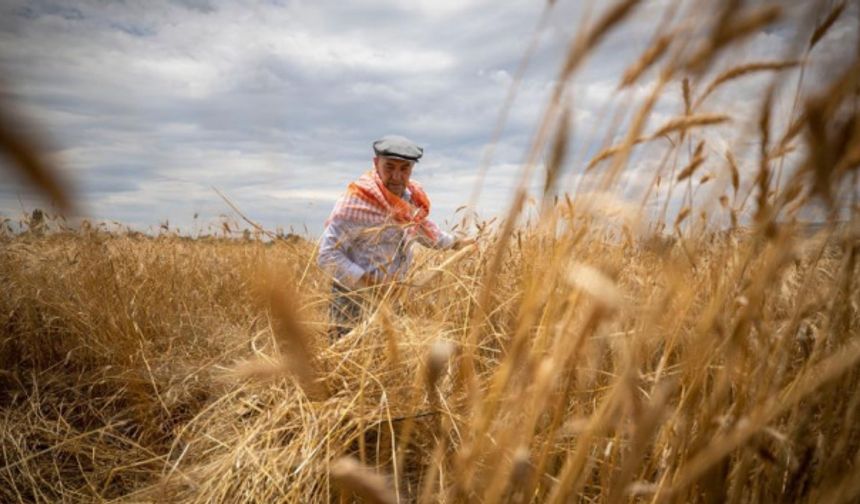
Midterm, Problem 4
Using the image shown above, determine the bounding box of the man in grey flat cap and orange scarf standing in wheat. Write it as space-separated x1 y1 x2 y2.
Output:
318 135 474 339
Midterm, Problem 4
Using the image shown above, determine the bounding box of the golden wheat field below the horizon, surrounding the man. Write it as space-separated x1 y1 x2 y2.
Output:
0 222 860 502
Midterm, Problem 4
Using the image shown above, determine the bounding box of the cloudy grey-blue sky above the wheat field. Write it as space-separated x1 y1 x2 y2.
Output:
0 0 857 235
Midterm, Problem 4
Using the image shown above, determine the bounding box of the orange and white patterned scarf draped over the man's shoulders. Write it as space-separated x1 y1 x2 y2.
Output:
325 170 439 242
